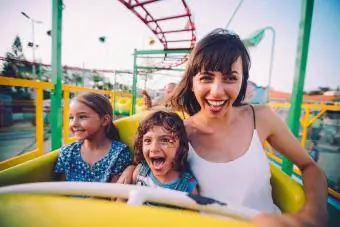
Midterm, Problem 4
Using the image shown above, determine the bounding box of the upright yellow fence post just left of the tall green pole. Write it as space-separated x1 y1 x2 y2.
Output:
35 88 44 156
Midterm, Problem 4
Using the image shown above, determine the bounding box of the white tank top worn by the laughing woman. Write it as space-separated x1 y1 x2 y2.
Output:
188 129 280 213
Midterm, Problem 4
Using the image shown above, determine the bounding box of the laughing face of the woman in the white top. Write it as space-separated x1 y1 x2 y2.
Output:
192 57 243 117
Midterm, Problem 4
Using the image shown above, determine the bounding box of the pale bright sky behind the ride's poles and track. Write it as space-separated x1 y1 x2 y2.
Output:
0 0 340 92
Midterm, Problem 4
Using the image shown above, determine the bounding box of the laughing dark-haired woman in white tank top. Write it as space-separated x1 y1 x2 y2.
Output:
168 29 327 226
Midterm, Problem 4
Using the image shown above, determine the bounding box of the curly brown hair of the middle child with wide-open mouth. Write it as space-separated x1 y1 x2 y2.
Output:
134 111 189 172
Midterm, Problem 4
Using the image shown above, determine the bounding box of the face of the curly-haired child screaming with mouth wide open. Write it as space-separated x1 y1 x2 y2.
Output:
143 126 179 177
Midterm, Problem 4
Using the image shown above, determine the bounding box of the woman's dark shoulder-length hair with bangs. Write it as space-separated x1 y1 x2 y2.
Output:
167 28 250 115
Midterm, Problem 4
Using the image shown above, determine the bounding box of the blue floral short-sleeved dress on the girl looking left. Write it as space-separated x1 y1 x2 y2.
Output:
55 140 132 182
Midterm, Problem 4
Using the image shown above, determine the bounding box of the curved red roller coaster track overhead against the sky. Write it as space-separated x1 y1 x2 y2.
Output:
119 0 196 68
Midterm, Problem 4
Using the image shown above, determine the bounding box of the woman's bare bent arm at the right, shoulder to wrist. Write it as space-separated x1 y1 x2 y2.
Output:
256 106 327 226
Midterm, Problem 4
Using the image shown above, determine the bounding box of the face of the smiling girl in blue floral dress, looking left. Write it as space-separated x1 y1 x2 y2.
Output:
70 100 104 140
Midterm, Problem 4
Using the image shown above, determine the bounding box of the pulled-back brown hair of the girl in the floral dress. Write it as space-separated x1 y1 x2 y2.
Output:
75 93 119 140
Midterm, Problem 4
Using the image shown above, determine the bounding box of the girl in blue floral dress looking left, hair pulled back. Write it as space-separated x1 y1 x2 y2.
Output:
55 93 132 182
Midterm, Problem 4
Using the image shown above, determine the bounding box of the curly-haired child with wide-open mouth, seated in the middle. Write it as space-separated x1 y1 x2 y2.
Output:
133 111 197 194
